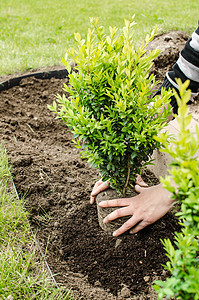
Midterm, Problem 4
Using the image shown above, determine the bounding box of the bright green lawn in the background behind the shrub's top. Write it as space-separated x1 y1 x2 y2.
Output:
0 0 198 75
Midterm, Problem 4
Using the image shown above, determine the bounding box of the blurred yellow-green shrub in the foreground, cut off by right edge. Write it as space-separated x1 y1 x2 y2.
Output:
155 80 199 300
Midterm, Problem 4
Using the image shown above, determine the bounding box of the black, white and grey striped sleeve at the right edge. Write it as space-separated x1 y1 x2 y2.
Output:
155 27 199 113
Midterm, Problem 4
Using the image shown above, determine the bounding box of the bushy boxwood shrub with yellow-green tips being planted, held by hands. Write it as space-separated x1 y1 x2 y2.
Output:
49 18 171 194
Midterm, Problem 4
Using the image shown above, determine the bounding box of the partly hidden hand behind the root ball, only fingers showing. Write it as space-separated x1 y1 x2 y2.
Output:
90 175 148 204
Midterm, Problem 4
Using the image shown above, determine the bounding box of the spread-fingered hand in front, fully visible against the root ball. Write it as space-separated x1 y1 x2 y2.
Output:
99 184 174 236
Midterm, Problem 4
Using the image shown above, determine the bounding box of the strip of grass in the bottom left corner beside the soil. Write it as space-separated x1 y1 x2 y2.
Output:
0 146 74 300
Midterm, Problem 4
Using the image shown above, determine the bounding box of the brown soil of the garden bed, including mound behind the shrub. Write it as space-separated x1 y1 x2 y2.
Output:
0 32 191 300
